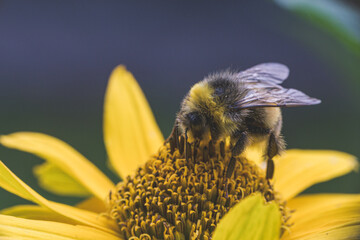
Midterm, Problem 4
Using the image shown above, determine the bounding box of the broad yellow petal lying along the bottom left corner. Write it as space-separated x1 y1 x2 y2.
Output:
0 215 121 240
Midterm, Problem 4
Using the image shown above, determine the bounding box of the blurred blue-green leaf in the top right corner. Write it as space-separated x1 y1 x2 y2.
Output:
275 0 360 56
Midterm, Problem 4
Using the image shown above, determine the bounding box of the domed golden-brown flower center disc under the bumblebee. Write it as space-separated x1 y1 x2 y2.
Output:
109 137 282 240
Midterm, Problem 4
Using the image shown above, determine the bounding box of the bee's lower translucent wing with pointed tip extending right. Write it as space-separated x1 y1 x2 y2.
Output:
235 85 321 108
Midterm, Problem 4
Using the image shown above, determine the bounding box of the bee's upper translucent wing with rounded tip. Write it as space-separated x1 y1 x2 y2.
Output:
237 63 289 88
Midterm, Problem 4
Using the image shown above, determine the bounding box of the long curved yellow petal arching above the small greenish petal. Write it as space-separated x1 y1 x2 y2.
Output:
0 132 114 200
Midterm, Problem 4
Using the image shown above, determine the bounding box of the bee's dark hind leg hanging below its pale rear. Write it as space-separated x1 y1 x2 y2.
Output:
266 132 284 180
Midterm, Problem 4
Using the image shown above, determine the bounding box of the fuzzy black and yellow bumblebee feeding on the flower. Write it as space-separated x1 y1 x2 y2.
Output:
170 63 321 179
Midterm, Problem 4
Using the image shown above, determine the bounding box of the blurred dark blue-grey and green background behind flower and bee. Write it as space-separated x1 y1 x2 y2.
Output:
0 0 360 209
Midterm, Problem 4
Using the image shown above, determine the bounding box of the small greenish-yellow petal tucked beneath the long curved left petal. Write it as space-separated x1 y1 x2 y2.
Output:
33 162 91 197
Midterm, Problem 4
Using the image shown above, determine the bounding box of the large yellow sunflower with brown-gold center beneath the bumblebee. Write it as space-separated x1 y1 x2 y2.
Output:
0 66 360 240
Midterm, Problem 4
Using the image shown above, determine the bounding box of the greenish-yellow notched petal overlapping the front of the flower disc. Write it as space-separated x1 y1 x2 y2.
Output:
213 194 281 240
